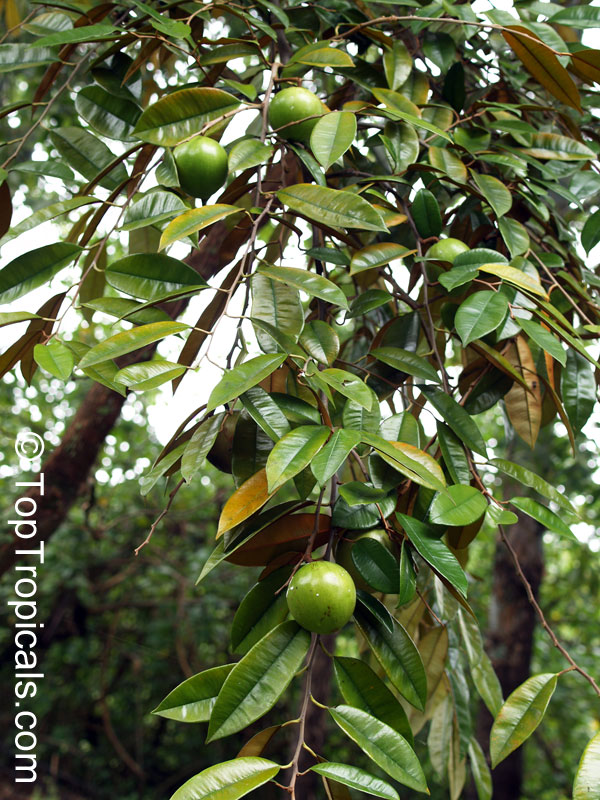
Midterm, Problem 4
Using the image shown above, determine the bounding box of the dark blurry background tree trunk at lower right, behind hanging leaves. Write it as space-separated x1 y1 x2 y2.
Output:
477 516 544 800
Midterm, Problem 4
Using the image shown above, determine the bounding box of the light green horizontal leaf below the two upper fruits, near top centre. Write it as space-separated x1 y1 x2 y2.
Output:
277 183 387 232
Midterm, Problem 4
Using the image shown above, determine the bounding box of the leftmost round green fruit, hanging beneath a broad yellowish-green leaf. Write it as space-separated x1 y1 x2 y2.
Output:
173 136 227 200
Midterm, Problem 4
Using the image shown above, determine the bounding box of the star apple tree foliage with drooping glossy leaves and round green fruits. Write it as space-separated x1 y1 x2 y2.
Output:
0 0 600 800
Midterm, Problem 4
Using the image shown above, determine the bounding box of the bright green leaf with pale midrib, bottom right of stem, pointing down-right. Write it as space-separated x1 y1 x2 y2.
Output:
329 706 428 792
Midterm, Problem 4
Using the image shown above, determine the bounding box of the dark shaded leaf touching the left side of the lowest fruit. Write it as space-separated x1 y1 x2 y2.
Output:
231 567 290 655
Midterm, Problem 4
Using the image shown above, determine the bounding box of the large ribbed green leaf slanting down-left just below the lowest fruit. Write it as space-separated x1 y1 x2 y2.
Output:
207 620 310 742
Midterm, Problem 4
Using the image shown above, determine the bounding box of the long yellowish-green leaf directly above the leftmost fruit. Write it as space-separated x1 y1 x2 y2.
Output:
133 86 239 147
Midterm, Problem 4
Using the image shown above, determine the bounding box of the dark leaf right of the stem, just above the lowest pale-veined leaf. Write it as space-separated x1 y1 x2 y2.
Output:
333 656 413 746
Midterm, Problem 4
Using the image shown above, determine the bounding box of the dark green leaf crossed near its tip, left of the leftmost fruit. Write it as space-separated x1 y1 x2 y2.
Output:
48 126 127 191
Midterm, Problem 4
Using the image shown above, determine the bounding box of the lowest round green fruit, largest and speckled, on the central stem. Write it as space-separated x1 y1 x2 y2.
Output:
286 561 356 633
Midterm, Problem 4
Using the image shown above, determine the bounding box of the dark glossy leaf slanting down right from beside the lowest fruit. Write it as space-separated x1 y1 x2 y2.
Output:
354 606 427 711
